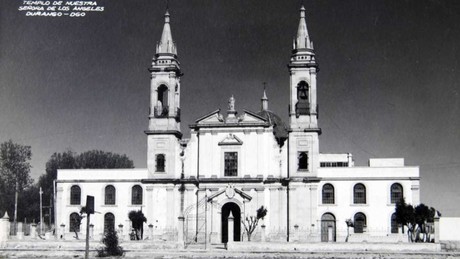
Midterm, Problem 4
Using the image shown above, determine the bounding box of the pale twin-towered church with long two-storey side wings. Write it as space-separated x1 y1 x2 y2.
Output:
55 7 420 246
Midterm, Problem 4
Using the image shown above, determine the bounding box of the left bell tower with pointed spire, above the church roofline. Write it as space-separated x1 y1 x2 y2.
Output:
145 10 183 178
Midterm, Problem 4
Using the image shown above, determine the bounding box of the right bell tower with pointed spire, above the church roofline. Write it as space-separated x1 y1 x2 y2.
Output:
288 6 321 177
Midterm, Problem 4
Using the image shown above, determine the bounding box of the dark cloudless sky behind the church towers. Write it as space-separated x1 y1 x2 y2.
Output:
0 0 460 216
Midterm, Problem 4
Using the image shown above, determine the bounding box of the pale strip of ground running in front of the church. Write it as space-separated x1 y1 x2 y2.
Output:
0 241 460 259
